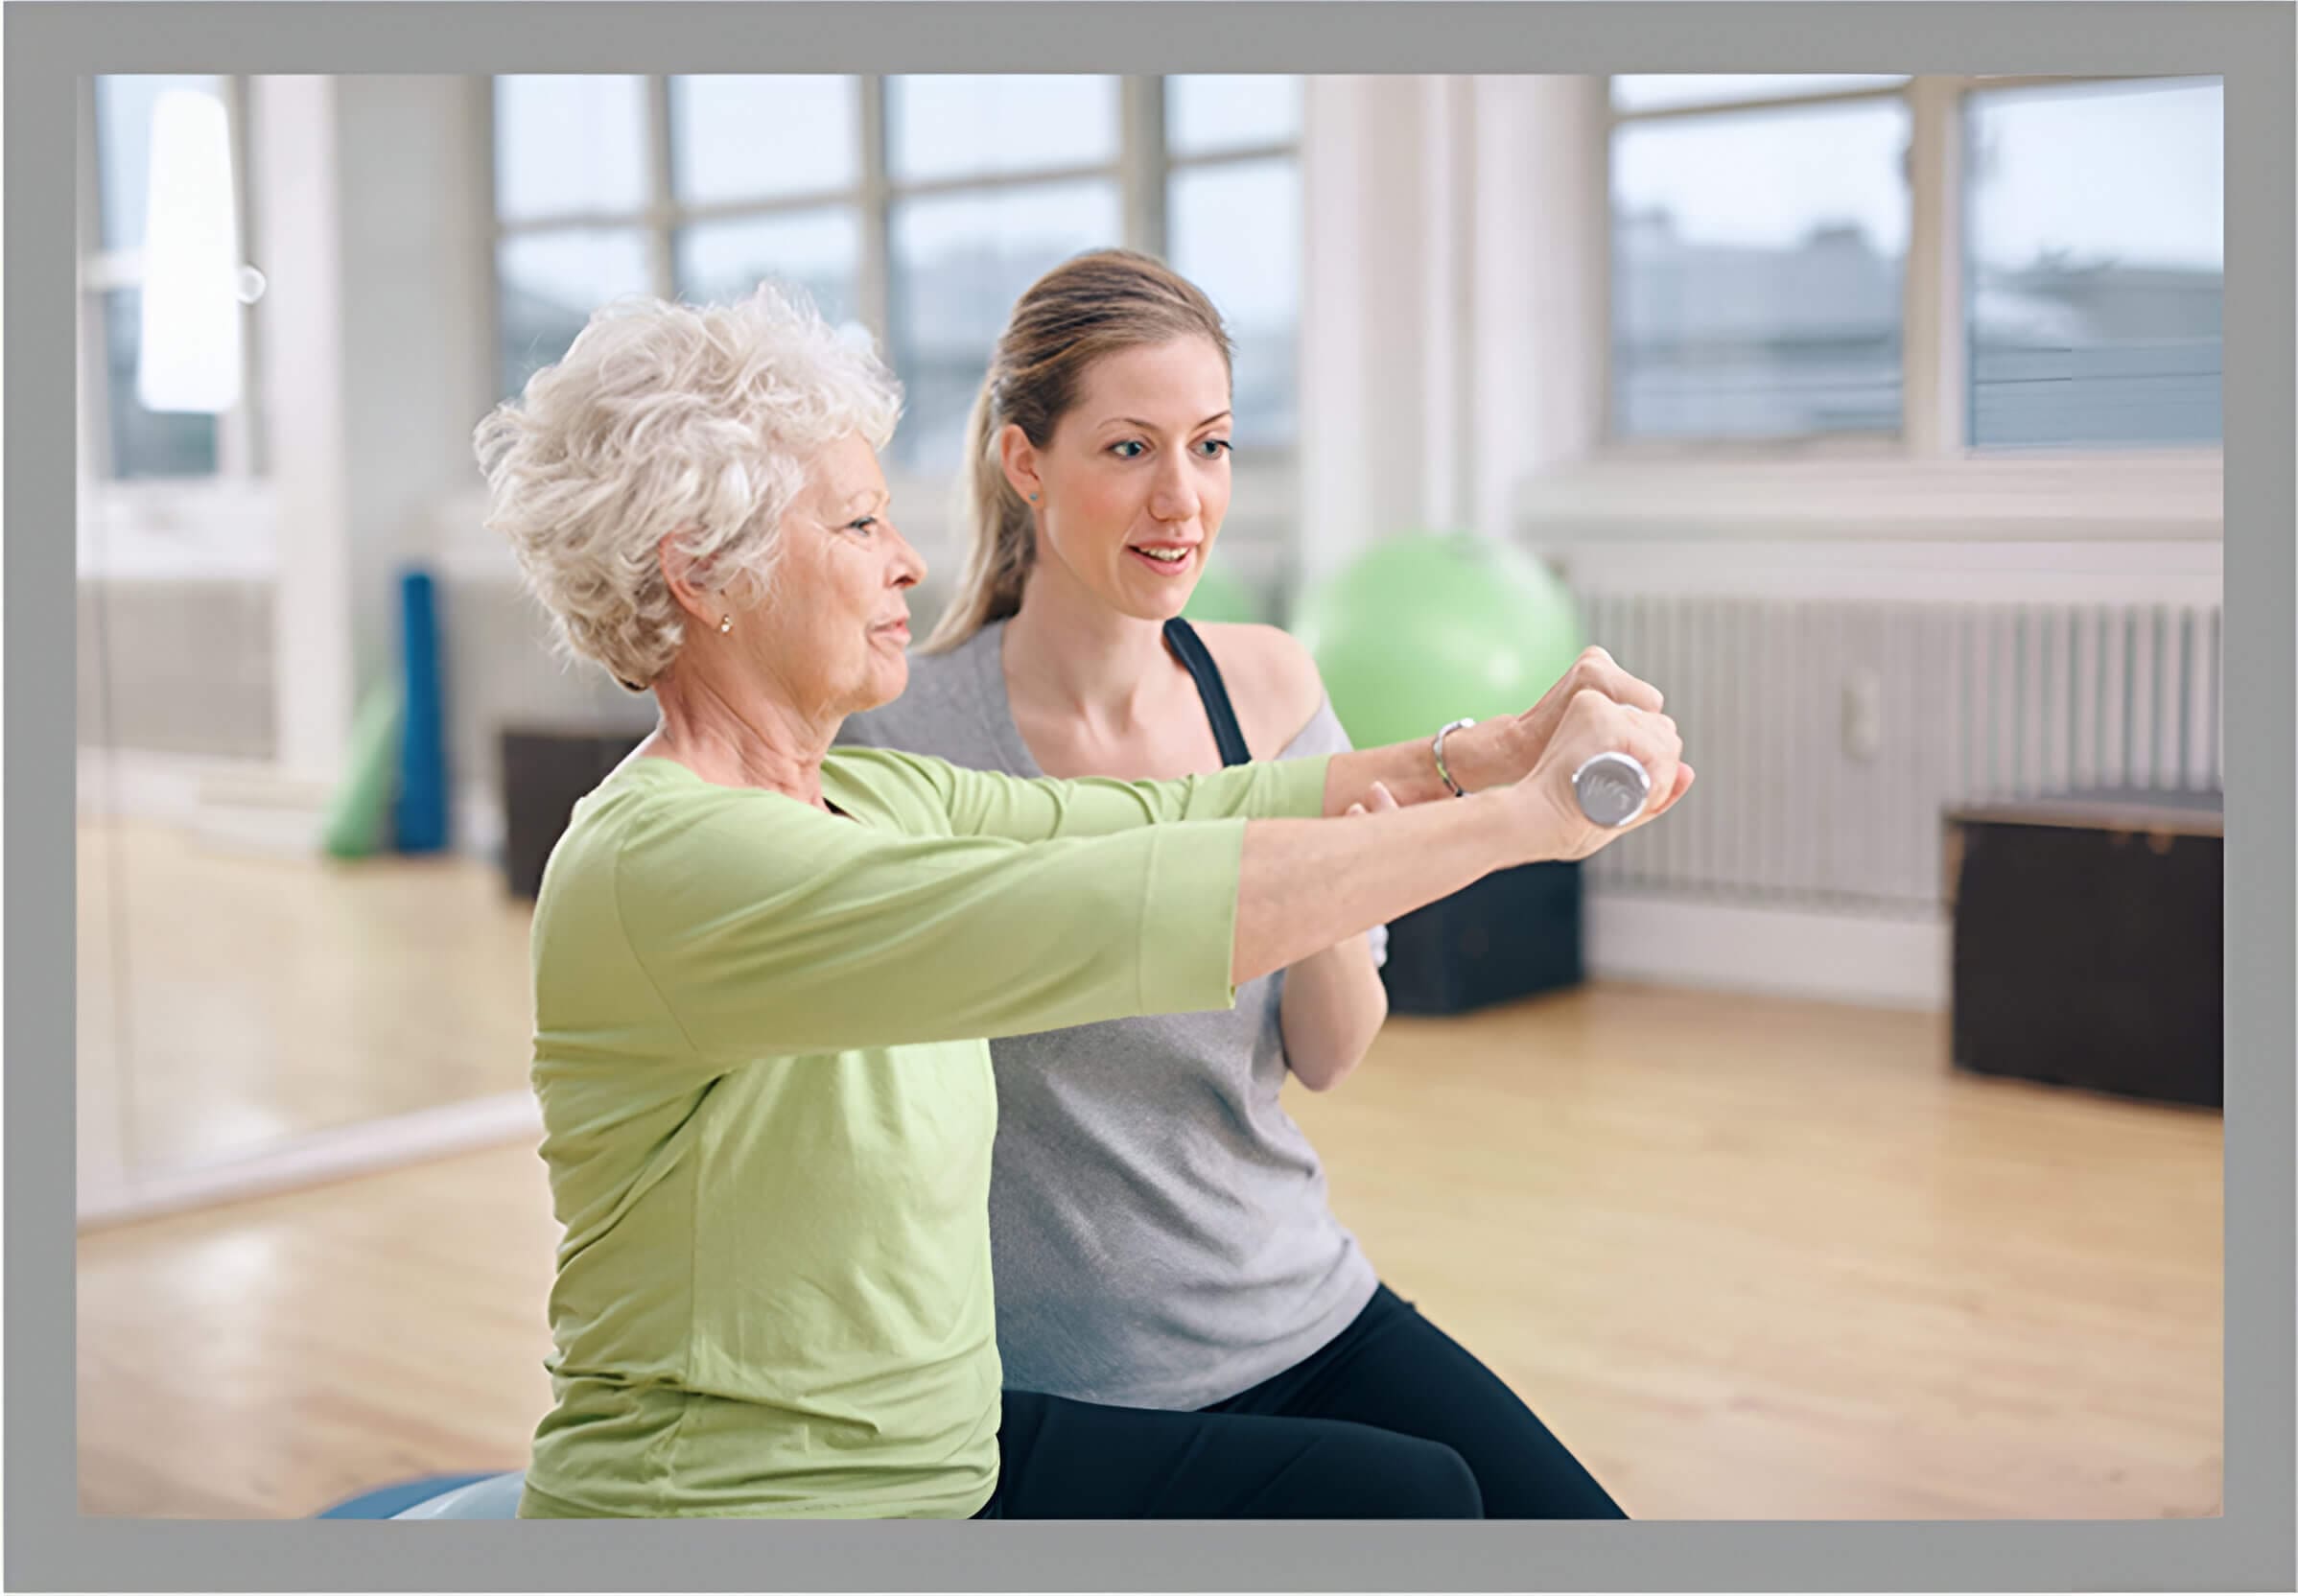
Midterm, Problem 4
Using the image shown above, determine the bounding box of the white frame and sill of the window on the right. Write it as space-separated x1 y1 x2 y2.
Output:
1516 74 2224 540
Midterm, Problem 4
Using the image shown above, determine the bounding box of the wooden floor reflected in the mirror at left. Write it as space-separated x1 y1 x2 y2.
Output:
76 816 533 1186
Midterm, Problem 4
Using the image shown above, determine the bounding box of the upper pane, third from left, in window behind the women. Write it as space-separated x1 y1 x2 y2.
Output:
884 74 1116 181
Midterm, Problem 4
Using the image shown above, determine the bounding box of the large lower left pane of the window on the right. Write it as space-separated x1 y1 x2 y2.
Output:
1611 101 1908 437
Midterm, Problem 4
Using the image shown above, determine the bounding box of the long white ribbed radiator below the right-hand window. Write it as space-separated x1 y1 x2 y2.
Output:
1574 588 2224 920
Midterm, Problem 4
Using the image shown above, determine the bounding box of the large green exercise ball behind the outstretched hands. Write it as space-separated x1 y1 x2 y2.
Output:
1292 533 1581 747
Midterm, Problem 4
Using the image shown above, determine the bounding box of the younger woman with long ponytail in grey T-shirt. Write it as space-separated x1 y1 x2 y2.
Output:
841 250 1659 1517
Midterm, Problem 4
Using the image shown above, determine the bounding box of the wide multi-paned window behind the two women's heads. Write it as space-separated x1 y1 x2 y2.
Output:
494 74 1301 474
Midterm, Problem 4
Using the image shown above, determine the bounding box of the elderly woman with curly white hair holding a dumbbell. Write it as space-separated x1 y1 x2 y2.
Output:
478 290 1689 1517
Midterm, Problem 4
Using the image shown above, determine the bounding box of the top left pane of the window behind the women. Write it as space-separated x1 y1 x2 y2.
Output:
494 76 648 221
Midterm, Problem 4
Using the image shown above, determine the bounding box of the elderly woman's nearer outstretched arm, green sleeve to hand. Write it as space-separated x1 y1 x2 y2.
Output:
583 692 1682 1058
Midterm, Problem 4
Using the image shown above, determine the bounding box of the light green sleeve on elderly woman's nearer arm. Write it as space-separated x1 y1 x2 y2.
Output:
597 770 1315 1060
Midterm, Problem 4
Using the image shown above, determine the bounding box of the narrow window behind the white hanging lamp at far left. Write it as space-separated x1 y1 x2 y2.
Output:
78 74 253 481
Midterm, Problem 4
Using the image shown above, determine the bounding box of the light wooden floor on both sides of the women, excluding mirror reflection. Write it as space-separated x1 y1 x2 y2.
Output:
78 987 2222 1517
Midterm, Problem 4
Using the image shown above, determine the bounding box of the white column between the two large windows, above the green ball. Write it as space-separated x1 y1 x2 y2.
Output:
1299 76 1611 582
